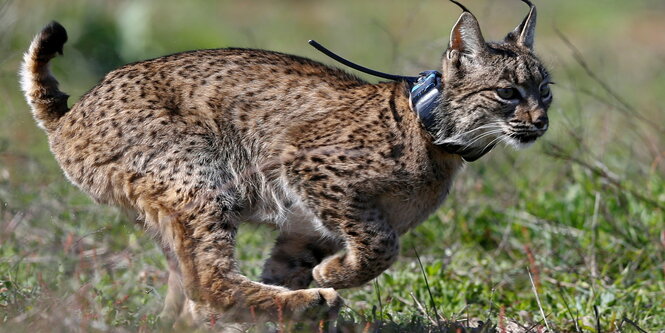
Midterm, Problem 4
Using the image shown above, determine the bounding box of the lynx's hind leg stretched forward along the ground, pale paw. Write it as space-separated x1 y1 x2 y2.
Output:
160 198 342 323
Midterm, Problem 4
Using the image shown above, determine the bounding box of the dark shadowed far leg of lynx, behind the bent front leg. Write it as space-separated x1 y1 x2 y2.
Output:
261 232 341 290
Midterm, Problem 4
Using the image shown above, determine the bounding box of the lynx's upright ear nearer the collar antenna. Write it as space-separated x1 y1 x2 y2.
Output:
449 11 487 57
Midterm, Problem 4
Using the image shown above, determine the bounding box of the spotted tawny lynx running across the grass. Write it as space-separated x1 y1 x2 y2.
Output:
21 0 552 322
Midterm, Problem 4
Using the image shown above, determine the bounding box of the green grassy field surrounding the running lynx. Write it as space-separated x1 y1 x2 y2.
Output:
0 0 665 332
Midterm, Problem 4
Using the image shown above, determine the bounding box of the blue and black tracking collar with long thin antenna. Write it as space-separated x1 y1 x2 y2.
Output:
309 40 494 162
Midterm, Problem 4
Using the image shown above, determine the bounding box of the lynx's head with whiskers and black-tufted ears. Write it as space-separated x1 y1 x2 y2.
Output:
435 0 552 161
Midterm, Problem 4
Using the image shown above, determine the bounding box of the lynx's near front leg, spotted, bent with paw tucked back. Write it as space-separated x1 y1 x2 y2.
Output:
287 153 399 289
